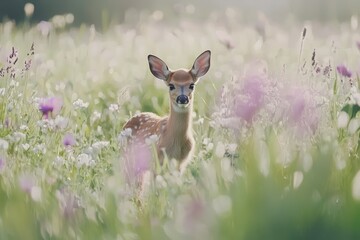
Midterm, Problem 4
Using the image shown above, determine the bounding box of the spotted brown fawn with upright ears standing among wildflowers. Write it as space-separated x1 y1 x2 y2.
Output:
123 50 211 171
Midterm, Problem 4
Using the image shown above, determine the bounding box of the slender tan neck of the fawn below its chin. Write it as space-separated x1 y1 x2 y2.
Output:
166 101 193 139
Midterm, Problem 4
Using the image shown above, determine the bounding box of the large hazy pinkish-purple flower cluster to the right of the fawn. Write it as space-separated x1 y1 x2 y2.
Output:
213 62 321 133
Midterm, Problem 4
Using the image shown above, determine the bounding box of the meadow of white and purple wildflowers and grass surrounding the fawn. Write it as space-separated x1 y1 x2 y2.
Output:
0 9 360 240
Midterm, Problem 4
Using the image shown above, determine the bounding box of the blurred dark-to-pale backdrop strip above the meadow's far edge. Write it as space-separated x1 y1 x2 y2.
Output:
0 0 360 26
